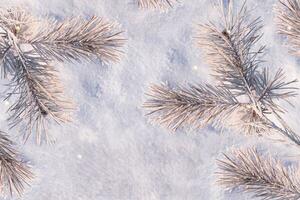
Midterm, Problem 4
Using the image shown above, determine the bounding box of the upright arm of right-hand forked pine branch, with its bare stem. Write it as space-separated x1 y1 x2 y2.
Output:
198 1 300 145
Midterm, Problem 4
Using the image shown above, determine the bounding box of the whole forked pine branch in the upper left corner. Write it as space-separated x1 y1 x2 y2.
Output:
0 8 125 143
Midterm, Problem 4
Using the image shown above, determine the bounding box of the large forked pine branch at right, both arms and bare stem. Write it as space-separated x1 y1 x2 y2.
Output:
144 1 300 145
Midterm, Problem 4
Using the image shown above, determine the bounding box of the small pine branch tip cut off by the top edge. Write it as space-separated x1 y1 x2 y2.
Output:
138 0 178 10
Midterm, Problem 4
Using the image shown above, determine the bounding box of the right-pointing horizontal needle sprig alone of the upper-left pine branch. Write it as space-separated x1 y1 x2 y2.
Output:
25 16 125 62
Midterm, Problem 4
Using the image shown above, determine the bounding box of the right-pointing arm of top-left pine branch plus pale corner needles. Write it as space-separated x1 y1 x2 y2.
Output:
0 8 125 62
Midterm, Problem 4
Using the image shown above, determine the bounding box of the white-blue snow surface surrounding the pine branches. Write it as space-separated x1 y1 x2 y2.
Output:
0 0 300 200
